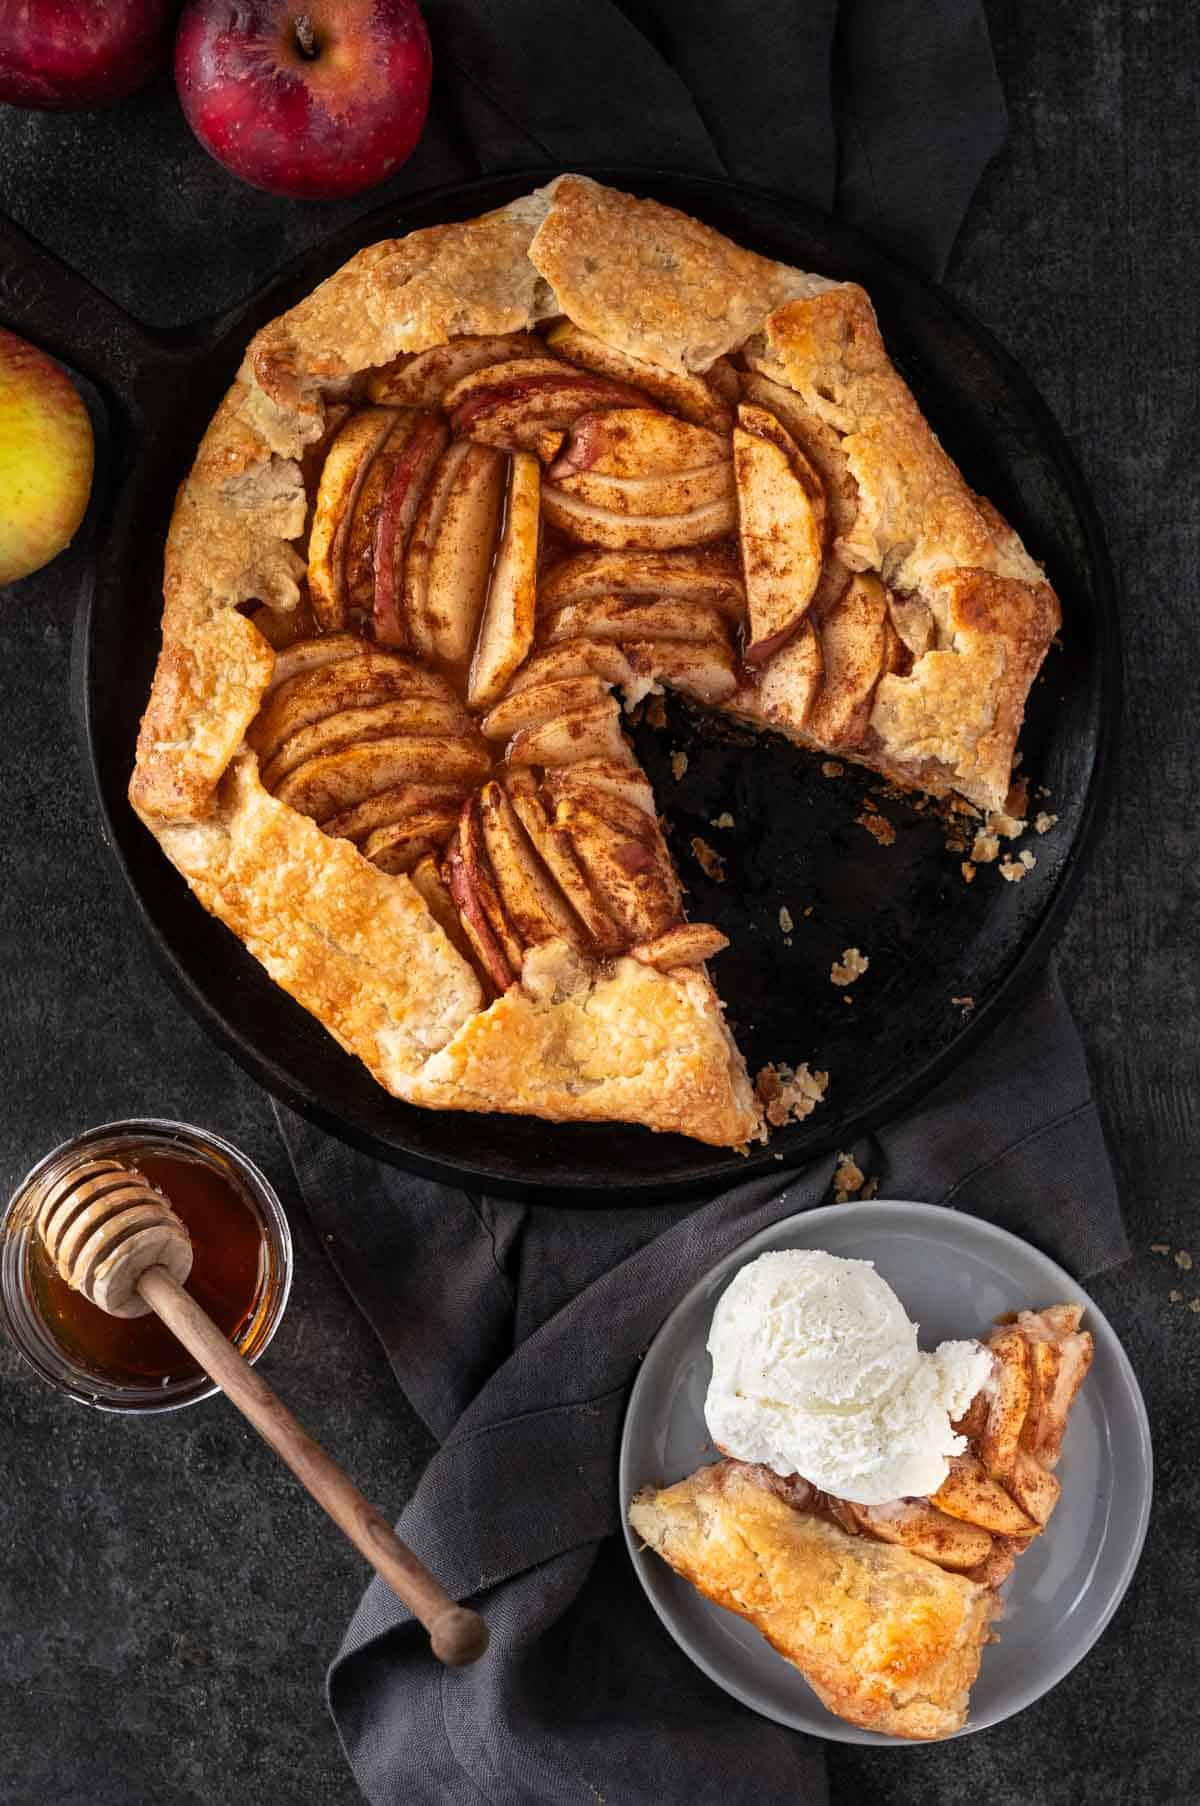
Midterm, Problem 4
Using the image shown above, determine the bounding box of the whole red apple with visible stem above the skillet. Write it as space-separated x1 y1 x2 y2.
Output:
175 0 432 200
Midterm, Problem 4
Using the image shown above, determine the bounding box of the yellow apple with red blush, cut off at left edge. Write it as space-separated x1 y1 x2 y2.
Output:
0 329 92 583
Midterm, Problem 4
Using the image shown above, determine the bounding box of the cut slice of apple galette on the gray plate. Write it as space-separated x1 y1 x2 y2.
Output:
629 1304 1092 1739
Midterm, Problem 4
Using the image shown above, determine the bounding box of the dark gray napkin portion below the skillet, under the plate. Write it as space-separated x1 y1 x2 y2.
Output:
278 975 1128 1806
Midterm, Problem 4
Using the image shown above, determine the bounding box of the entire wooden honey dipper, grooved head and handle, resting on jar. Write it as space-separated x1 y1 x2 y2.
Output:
36 1158 488 1667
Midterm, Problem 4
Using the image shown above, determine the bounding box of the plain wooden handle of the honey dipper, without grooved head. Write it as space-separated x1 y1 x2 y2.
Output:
137 1266 488 1667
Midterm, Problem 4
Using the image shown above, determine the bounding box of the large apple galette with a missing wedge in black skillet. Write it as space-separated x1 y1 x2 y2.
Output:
130 175 1059 1145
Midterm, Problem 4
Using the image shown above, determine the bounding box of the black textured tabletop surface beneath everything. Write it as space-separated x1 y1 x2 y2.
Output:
0 0 1200 1806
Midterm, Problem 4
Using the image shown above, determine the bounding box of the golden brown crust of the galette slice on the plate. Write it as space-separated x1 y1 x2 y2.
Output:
629 1463 998 1739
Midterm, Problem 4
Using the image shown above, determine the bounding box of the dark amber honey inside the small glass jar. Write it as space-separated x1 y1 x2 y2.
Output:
29 1147 269 1385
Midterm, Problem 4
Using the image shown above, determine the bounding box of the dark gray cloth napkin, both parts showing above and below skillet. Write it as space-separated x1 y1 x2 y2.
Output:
278 0 1124 1806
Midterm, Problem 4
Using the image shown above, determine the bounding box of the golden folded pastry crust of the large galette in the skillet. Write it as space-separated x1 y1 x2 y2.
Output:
130 177 1057 1145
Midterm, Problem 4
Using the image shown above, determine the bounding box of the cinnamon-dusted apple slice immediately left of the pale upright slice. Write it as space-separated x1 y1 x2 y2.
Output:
425 444 508 668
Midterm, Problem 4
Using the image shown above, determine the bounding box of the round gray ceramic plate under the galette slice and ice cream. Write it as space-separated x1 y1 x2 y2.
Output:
620 1199 1151 1748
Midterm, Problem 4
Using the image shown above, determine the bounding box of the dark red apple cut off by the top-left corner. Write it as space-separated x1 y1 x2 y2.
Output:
0 0 175 108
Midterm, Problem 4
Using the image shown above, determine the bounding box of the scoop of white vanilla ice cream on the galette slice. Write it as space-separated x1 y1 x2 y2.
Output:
705 1248 992 1504
